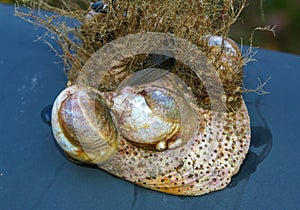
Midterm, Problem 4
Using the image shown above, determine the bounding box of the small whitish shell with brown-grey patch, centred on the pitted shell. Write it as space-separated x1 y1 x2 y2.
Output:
111 87 182 151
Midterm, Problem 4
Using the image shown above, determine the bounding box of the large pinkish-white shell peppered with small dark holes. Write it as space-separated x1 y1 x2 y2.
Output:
101 100 250 195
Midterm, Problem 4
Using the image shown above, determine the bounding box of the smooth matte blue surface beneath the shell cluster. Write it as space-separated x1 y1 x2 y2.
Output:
0 4 300 209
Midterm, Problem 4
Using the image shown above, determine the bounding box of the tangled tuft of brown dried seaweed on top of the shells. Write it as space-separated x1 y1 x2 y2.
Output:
16 0 247 111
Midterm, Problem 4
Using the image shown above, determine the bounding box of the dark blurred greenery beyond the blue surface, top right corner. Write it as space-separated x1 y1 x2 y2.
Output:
0 0 300 54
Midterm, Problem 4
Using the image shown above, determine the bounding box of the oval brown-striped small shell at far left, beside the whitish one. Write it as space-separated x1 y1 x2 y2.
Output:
52 86 118 164
